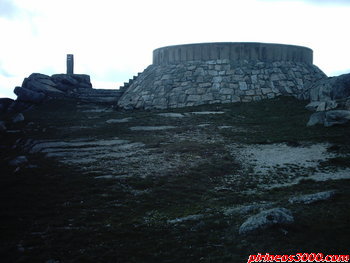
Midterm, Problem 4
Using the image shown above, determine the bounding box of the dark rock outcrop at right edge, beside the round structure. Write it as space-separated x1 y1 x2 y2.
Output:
306 74 350 127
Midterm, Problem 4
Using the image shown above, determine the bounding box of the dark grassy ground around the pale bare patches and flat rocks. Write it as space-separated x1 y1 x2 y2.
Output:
0 98 350 262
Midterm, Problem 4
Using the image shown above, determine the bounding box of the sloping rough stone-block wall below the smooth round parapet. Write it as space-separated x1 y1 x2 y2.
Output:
118 59 326 109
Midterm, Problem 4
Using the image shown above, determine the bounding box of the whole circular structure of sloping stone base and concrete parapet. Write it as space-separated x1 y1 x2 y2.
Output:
118 42 326 109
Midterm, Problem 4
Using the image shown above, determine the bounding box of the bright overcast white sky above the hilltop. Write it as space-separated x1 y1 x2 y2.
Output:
0 0 350 97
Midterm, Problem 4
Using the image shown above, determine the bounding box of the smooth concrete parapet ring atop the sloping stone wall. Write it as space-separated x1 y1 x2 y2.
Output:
153 42 313 65
